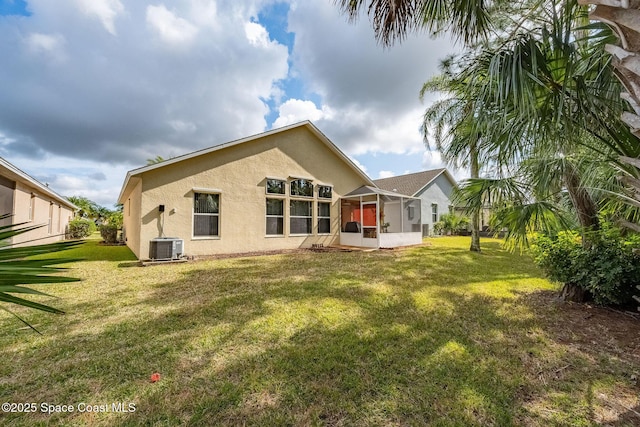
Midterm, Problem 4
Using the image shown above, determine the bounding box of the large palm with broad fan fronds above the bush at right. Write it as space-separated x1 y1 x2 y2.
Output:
421 1 640 244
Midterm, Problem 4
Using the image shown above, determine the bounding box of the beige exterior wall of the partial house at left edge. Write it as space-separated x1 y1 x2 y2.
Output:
12 182 73 245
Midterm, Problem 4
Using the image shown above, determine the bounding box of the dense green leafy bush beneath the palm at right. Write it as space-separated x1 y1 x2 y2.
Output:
531 226 640 305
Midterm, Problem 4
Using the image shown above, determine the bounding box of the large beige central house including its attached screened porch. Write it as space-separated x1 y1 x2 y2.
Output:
118 121 421 259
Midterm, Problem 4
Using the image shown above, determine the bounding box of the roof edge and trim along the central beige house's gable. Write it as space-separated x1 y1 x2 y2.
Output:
118 120 374 203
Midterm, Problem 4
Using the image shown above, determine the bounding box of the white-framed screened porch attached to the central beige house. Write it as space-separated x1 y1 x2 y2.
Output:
340 186 422 248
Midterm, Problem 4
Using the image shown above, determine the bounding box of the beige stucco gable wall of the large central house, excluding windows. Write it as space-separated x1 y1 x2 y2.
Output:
124 126 367 259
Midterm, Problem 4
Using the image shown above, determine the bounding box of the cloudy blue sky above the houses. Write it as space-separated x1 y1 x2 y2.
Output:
0 0 460 208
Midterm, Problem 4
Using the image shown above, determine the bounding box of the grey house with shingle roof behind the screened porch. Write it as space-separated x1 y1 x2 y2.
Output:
373 168 457 236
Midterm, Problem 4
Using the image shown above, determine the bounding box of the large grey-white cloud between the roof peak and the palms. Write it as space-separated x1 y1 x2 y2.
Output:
289 1 452 155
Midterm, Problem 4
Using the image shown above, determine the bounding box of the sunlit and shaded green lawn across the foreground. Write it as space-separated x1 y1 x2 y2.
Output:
0 238 640 426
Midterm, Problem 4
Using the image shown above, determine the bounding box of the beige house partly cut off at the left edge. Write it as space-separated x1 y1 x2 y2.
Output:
0 158 77 246
